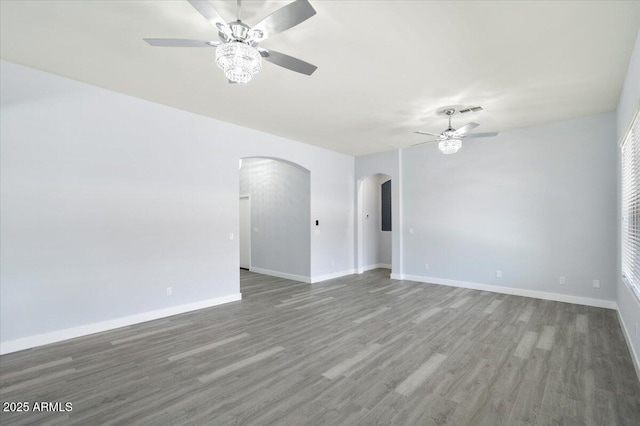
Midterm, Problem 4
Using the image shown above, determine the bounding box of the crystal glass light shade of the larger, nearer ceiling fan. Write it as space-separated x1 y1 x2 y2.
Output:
216 41 262 83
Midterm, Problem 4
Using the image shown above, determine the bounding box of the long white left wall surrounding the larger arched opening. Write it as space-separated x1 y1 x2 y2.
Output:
0 61 354 352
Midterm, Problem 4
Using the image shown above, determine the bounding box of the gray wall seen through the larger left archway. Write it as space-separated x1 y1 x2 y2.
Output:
240 158 311 280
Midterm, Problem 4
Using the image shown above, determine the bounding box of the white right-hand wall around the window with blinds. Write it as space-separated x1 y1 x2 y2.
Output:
612 31 640 377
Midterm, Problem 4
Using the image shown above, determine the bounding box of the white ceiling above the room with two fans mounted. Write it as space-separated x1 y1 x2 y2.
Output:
0 0 640 155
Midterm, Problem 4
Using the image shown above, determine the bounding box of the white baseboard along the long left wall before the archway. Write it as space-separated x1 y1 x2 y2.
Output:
0 293 242 355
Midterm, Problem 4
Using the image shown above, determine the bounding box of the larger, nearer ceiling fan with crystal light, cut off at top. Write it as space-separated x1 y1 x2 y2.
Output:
144 0 317 83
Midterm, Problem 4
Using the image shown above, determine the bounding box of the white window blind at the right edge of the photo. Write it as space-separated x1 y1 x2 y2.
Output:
622 112 640 297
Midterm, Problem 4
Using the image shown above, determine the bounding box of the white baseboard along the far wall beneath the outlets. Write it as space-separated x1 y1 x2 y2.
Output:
398 275 618 309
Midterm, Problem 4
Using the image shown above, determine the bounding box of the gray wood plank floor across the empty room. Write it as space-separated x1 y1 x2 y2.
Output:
0 270 640 425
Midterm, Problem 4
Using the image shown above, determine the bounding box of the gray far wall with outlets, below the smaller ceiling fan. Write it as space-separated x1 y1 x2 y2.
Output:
402 113 616 300
